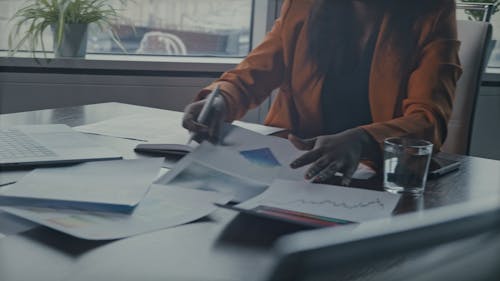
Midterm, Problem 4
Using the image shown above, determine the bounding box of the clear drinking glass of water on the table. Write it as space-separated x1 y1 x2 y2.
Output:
384 137 432 195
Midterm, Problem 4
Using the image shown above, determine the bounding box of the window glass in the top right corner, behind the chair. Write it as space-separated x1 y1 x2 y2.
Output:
457 0 500 68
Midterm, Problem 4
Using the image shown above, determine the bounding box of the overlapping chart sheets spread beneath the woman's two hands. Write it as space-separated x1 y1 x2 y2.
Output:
156 127 400 226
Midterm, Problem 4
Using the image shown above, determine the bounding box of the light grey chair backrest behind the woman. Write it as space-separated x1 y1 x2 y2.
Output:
442 20 492 155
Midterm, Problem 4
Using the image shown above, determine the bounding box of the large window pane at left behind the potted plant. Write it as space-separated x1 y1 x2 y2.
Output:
0 0 253 57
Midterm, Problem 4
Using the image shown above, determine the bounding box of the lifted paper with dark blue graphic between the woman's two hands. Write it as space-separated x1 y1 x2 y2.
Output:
156 126 375 202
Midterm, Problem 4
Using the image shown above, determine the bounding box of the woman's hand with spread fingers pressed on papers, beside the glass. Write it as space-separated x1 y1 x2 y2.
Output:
288 128 378 186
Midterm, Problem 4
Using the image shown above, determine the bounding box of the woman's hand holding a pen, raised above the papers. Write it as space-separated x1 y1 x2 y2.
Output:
182 96 226 143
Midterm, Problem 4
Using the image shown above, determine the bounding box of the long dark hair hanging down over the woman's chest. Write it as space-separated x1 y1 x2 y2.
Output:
308 0 446 72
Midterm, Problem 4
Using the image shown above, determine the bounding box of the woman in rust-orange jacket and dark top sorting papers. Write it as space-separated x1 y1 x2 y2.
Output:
183 0 461 185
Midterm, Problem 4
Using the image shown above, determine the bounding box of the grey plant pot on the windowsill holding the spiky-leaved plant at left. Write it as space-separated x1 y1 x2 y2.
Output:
51 24 88 58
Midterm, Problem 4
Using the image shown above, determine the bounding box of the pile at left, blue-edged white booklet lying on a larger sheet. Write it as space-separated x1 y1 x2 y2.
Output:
0 158 231 240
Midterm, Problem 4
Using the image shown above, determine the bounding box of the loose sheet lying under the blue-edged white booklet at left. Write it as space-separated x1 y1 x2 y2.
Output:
2 185 231 240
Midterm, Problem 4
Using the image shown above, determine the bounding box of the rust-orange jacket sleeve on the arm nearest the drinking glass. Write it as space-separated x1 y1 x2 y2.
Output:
362 1 462 150
